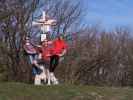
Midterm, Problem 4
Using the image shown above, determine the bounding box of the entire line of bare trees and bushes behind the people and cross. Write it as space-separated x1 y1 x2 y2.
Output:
0 0 133 86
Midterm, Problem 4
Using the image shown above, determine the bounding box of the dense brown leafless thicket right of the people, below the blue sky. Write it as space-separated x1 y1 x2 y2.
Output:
56 28 133 86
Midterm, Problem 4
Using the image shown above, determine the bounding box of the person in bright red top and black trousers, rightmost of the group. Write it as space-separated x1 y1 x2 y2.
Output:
49 36 67 84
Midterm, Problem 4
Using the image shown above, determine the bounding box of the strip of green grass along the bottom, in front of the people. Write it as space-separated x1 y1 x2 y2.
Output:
0 83 133 100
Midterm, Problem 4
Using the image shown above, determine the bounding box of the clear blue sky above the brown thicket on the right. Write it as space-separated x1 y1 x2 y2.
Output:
83 0 133 29
